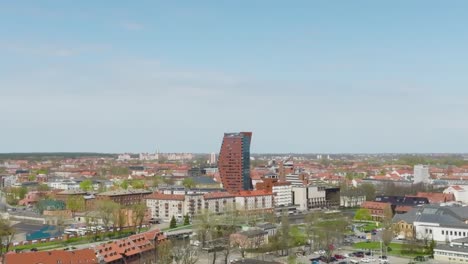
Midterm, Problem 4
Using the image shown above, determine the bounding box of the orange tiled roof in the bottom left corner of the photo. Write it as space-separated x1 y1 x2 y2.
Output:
3 249 99 264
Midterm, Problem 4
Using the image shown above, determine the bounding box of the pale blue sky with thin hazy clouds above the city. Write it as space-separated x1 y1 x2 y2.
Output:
0 0 468 153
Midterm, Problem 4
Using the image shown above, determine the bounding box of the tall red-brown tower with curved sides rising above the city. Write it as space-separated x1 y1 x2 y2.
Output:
218 132 253 193
